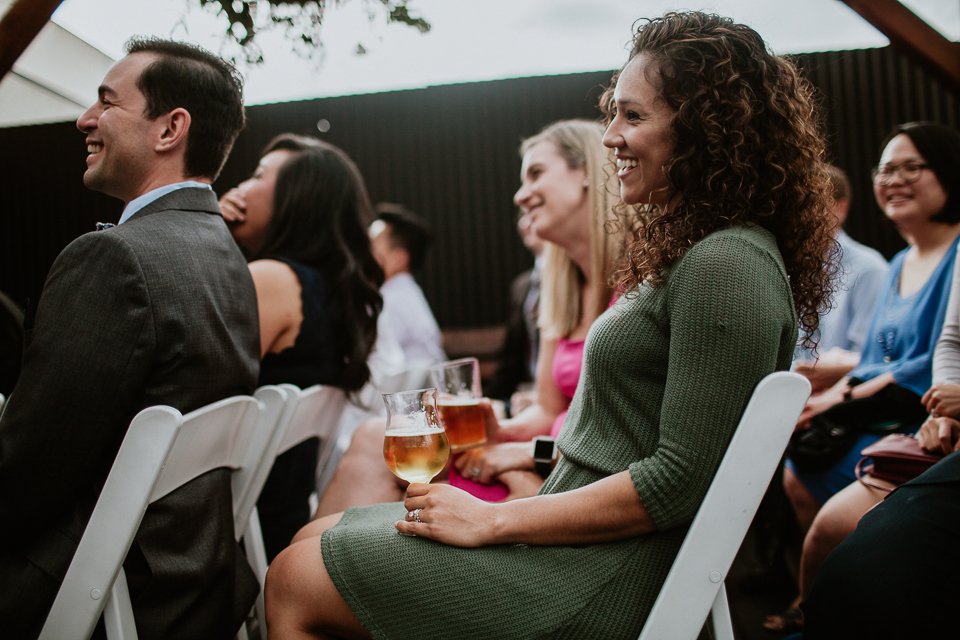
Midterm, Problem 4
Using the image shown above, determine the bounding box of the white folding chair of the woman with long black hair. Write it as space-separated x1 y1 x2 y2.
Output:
242 384 347 637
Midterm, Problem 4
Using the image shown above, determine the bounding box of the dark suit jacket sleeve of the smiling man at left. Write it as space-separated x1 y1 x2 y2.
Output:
0 232 155 539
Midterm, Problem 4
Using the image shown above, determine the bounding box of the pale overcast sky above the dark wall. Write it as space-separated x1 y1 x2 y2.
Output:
53 0 960 104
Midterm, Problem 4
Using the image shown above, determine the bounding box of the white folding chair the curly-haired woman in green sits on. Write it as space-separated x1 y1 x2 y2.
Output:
640 371 810 640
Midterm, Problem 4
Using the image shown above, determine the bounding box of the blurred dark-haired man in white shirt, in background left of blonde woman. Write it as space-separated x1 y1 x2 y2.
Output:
370 203 447 367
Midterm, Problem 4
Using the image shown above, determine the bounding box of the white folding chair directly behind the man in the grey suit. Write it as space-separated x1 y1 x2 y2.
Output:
40 388 286 640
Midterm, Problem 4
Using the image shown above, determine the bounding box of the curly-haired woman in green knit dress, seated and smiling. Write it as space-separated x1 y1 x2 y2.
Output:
266 13 832 638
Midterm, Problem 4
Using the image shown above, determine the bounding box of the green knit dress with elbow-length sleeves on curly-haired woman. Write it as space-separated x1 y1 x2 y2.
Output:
321 226 797 640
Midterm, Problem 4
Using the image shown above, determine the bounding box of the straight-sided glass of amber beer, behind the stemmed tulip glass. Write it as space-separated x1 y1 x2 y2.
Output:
430 358 487 451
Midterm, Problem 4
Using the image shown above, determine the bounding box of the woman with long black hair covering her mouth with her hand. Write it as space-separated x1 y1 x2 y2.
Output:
220 134 383 560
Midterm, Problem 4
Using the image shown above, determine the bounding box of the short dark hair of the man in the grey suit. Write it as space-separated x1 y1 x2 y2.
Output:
127 36 244 180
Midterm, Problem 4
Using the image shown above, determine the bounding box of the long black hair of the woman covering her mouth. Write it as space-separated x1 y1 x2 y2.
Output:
251 134 383 391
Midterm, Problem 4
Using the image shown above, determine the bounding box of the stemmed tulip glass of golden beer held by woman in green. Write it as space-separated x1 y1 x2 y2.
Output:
383 389 450 483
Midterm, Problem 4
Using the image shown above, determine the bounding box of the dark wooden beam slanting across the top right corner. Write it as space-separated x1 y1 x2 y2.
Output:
843 0 960 94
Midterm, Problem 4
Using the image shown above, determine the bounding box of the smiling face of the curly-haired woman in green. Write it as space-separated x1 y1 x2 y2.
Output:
603 55 676 205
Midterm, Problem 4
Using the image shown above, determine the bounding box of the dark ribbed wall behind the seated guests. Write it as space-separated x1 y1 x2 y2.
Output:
0 47 960 328
